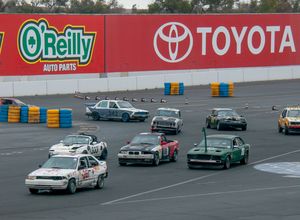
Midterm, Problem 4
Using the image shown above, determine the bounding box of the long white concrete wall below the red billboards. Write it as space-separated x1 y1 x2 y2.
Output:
0 66 300 96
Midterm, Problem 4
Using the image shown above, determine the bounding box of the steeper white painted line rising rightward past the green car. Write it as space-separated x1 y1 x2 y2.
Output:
101 149 300 205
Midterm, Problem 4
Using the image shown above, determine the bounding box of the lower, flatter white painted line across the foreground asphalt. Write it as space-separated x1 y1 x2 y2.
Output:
103 185 300 205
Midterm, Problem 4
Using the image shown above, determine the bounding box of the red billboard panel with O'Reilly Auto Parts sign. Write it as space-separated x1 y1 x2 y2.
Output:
0 14 104 76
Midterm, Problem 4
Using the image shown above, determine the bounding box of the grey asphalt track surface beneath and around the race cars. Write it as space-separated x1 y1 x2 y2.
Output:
0 80 300 220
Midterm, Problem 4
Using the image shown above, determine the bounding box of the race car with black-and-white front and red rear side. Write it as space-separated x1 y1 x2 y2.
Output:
118 132 179 166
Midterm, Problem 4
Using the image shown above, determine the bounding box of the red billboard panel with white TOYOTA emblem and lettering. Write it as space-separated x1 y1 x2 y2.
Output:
106 14 300 72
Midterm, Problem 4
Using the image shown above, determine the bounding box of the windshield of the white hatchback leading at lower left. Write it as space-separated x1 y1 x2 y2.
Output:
42 157 77 170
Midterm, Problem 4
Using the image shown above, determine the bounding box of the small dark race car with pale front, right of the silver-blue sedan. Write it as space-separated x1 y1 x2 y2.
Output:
151 108 183 134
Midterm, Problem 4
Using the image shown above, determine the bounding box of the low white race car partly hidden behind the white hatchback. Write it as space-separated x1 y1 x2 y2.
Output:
49 133 108 160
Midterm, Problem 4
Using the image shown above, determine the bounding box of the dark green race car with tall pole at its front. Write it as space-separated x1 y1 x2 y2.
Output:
187 135 250 169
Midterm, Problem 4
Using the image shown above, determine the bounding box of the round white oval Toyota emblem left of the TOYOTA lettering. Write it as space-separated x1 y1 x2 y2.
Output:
153 22 193 63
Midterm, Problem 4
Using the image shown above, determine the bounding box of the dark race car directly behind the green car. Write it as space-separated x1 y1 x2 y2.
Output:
206 108 247 131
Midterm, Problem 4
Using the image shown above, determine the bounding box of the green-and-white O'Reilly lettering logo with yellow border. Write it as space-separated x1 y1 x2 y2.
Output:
18 19 96 66
